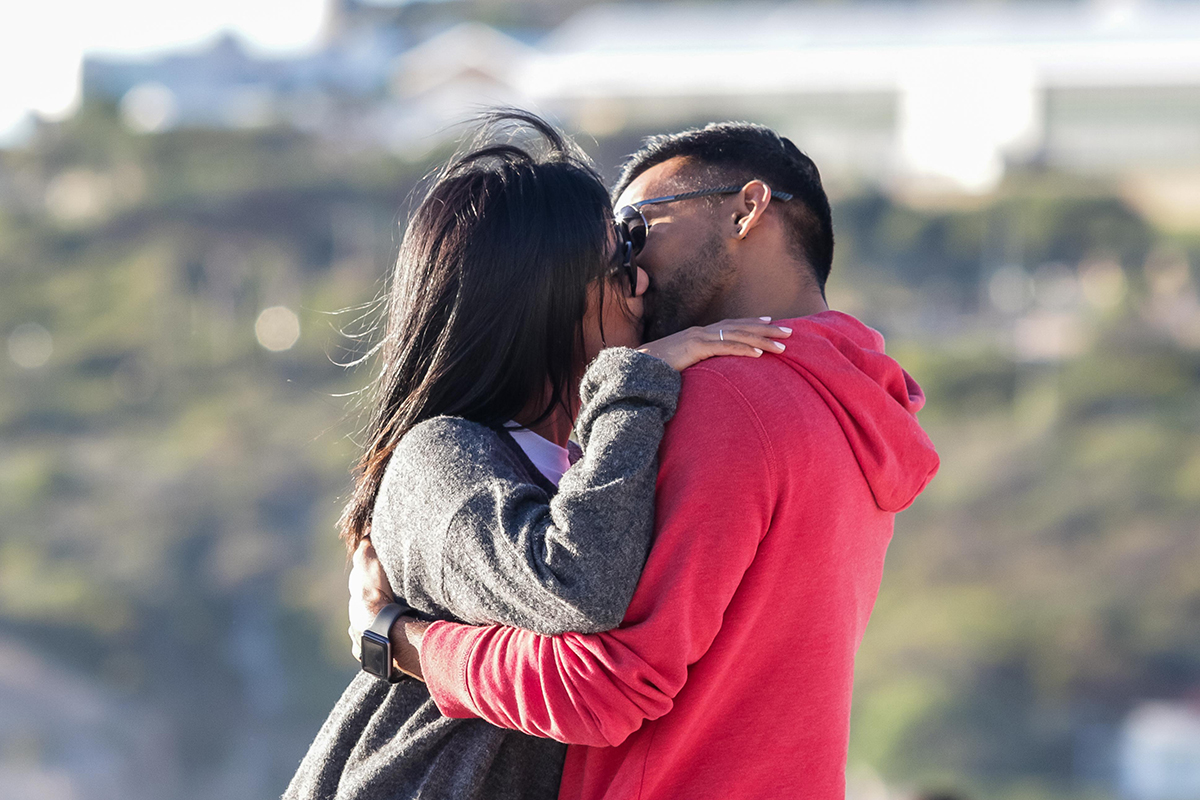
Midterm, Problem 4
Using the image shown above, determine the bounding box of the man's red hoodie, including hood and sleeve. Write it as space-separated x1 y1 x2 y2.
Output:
421 312 938 800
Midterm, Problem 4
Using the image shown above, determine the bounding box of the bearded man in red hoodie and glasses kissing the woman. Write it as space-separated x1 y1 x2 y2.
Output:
352 124 937 800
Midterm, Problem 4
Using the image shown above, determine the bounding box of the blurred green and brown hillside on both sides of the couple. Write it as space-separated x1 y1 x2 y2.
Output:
0 106 1200 799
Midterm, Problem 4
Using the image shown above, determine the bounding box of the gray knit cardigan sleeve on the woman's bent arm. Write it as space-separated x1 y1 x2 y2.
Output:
372 348 680 633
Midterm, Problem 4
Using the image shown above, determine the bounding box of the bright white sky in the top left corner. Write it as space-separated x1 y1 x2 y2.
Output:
0 0 326 145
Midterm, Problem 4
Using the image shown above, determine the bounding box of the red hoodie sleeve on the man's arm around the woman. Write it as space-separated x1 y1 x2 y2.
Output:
421 366 778 746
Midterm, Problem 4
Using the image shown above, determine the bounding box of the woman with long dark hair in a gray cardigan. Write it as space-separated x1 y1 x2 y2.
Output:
284 113 785 800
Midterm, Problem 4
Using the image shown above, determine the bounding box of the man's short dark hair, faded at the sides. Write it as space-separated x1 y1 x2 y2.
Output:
613 122 833 294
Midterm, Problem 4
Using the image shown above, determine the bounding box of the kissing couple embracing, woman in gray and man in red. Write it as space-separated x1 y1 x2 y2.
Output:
284 112 938 800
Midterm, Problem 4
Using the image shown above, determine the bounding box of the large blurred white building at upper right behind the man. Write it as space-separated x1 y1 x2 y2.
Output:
518 0 1200 191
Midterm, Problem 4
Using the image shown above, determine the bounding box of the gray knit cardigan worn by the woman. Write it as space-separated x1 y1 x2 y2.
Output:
283 348 680 800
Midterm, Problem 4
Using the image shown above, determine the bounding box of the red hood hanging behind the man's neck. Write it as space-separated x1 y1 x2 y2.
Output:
774 311 940 512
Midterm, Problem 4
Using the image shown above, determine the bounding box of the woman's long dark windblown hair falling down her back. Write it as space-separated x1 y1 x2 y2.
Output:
338 110 613 551
